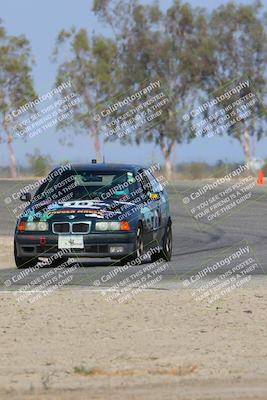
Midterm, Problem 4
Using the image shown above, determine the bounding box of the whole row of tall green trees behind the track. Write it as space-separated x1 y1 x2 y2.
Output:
0 0 267 177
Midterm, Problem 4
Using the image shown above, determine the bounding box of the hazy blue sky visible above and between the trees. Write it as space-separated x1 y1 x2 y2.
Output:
0 0 267 165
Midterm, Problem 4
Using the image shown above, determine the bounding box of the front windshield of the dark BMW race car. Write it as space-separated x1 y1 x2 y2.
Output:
33 170 138 201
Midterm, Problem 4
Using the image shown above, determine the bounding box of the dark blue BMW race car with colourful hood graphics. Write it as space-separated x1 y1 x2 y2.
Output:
14 163 172 268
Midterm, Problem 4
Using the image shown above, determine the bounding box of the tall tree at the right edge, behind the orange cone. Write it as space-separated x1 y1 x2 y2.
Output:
203 1 267 165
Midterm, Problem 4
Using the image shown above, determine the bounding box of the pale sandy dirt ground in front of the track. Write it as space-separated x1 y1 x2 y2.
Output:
0 239 267 400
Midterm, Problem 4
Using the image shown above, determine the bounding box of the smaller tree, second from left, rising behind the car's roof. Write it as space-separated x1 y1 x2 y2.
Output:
54 28 117 161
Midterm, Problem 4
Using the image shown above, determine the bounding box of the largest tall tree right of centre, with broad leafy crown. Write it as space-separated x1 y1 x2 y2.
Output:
93 0 213 176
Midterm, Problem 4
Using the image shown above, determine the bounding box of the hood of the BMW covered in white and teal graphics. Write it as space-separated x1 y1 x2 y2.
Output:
24 199 136 221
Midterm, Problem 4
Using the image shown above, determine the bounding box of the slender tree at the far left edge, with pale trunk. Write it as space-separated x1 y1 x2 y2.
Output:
0 21 35 178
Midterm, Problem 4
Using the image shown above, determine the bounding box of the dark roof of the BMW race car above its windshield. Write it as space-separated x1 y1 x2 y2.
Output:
53 163 143 172
